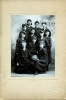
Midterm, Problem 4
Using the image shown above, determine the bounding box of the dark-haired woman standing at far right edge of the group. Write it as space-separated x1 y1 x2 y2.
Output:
44 29 52 64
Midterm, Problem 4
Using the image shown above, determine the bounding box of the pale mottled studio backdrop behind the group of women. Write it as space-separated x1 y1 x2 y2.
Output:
11 15 55 63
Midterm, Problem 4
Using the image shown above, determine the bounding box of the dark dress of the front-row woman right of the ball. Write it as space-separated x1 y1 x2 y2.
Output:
36 48 48 72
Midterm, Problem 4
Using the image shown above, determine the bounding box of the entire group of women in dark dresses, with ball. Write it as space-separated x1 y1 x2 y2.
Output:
14 19 51 74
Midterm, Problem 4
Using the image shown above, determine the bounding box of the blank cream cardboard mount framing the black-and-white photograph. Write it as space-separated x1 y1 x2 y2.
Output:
0 0 66 100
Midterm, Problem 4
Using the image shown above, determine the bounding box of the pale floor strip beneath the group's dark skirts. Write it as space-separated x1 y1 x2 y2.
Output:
11 64 55 77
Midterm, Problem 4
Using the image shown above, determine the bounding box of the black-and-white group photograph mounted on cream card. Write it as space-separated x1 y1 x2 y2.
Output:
11 15 55 77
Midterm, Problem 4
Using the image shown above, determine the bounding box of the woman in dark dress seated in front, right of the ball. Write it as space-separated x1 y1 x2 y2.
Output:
35 41 48 74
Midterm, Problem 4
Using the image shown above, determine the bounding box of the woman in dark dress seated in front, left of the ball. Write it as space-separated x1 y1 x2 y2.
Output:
14 41 34 74
